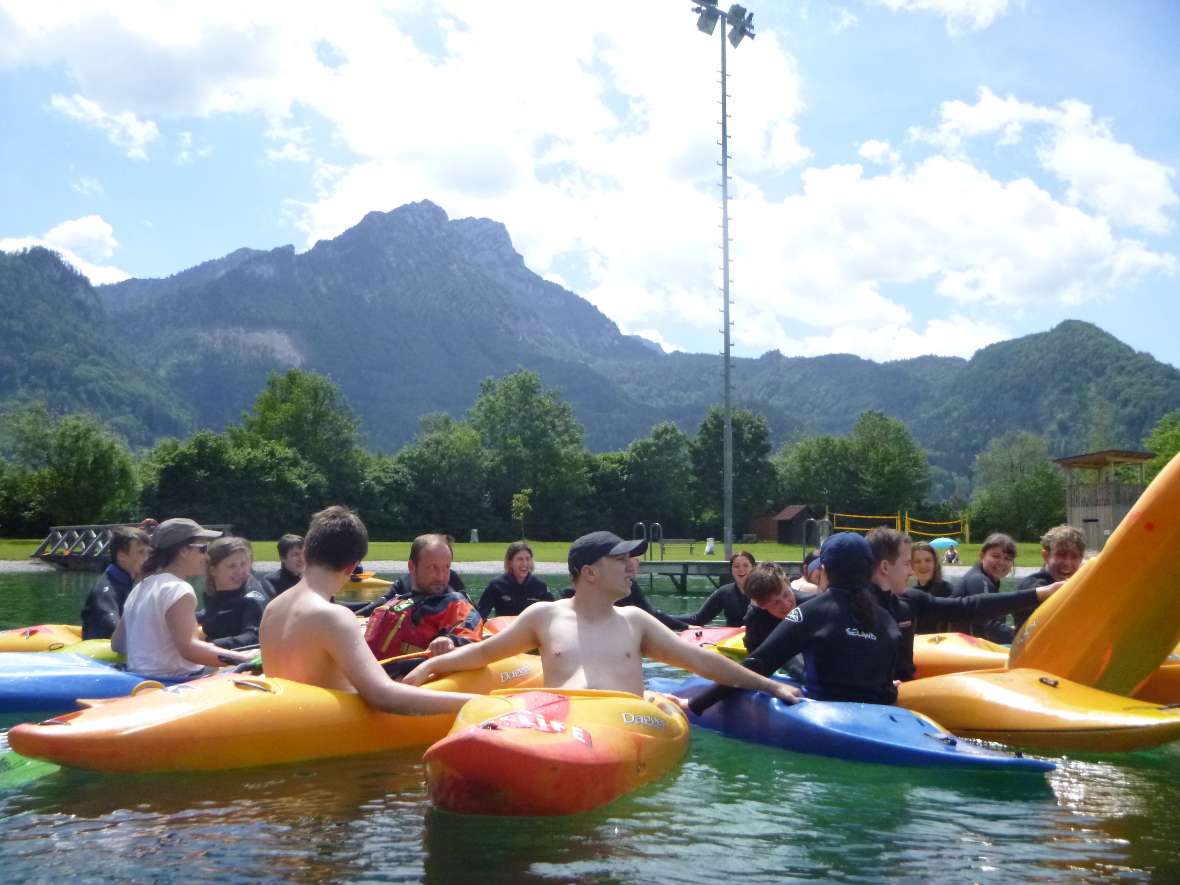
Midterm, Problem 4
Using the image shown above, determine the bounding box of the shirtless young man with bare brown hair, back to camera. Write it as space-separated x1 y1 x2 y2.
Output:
258 506 474 715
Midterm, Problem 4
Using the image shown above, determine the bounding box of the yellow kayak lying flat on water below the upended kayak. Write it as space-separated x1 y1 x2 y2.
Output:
897 669 1180 752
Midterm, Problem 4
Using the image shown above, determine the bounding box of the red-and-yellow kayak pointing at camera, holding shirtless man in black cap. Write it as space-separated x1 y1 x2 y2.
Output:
424 689 689 814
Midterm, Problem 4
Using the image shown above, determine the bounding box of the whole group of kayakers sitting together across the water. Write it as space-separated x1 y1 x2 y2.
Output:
76 506 1084 713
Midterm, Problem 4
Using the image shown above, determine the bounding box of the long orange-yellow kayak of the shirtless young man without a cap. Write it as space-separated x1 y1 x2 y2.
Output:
8 655 543 772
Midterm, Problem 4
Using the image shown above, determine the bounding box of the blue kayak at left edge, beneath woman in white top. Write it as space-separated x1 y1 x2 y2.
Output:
0 651 185 713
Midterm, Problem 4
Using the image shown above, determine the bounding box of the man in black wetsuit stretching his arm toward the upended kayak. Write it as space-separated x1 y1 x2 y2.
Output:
867 529 1061 682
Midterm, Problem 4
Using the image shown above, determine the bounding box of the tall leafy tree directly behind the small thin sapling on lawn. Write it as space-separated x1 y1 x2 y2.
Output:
468 371 590 538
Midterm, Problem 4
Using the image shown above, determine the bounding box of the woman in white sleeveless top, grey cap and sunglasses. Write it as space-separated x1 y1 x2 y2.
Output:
111 517 251 680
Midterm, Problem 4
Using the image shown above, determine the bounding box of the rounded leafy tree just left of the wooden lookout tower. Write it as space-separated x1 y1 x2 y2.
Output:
970 431 1066 540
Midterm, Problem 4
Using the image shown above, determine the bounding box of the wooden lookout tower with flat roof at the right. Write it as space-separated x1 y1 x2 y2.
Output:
1056 448 1155 551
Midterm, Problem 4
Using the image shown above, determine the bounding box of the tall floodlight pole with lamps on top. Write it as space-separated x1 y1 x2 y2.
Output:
693 0 754 559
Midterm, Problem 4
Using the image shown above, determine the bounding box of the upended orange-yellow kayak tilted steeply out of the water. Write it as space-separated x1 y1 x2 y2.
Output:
1008 455 1180 695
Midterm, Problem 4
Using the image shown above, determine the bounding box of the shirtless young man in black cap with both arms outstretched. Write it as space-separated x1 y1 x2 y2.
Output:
406 532 799 703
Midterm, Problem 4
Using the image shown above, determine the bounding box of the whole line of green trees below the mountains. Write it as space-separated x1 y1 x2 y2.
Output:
0 369 1180 539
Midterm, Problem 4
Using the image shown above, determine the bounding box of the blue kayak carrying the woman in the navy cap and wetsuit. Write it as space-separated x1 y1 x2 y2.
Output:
648 676 1056 772
